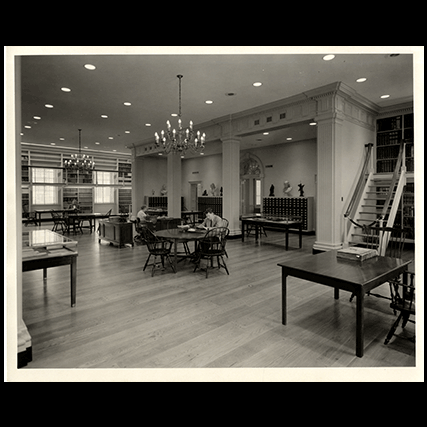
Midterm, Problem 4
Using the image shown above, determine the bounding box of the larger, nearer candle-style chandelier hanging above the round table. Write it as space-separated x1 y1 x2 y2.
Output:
154 74 206 154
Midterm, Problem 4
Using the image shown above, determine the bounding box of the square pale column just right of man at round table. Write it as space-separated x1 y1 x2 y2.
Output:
221 137 241 235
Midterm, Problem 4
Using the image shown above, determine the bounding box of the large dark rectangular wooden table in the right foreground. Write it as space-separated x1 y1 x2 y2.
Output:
278 251 412 357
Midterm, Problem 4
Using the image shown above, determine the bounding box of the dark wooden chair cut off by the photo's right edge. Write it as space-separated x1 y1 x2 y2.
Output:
384 272 415 344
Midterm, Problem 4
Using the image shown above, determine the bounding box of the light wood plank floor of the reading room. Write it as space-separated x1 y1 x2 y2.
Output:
23 224 415 378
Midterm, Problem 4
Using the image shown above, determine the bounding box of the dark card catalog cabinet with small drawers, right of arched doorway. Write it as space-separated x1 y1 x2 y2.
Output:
262 197 314 232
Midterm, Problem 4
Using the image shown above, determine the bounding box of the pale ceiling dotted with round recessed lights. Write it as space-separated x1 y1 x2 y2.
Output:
17 48 413 157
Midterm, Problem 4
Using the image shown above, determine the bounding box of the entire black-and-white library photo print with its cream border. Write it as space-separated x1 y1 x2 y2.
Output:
5 46 424 382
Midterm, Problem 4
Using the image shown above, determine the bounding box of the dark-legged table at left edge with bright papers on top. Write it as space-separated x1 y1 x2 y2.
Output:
22 230 78 307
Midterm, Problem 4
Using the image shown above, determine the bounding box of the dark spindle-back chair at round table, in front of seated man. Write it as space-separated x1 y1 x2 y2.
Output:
193 227 230 278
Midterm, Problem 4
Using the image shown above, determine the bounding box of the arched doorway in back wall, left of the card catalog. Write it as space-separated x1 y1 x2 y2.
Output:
240 153 264 214
